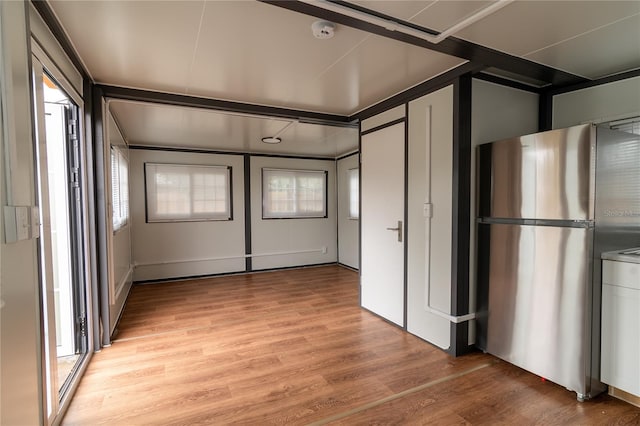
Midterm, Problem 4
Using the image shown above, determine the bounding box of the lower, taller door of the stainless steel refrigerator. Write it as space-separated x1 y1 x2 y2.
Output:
478 224 593 396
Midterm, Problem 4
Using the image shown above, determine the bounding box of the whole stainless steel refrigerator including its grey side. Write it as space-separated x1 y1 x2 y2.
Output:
476 125 640 400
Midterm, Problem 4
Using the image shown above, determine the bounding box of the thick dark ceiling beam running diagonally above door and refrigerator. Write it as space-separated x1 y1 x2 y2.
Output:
259 0 588 86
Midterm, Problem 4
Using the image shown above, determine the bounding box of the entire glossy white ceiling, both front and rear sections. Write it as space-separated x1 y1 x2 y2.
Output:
50 0 640 156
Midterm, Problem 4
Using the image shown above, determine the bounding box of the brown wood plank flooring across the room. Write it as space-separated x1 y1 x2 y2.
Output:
63 266 640 425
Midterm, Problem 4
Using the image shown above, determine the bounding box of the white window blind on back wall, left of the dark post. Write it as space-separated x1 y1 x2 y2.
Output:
145 163 231 222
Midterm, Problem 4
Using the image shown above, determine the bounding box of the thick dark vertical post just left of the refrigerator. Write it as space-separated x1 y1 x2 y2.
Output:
449 74 472 356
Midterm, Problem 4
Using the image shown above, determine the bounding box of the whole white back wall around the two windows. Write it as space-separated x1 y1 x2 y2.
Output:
129 149 337 281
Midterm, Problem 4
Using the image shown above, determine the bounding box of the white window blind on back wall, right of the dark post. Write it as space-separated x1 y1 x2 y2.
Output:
262 169 327 219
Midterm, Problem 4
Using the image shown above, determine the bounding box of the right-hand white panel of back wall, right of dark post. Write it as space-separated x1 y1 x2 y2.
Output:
251 156 338 270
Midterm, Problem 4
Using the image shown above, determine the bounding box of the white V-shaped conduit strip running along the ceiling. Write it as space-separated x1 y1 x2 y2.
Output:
299 0 514 44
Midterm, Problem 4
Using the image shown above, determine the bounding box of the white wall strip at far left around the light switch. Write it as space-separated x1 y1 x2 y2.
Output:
0 1 41 425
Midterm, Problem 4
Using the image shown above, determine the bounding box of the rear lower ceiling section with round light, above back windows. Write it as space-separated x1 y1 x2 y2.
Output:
109 100 358 158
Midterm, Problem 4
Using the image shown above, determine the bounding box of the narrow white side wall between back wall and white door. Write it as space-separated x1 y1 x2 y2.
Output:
336 153 360 269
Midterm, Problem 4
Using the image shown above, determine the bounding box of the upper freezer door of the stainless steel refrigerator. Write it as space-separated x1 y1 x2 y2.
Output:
478 125 595 220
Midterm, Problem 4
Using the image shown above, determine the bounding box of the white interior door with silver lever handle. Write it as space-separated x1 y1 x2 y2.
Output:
360 123 405 326
